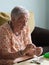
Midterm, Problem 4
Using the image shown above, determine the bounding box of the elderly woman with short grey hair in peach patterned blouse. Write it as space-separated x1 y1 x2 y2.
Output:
0 7 42 59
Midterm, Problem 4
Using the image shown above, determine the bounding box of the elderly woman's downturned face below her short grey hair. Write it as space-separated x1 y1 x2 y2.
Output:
15 15 28 30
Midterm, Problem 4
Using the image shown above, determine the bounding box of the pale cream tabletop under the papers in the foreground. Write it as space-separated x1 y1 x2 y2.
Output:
14 58 49 65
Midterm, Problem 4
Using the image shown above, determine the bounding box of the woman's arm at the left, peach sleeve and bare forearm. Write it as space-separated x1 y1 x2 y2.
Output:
0 29 21 59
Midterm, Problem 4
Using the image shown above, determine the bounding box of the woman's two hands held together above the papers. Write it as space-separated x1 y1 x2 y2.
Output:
23 44 43 57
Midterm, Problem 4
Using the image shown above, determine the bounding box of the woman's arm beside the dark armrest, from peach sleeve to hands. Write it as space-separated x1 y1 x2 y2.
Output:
24 25 43 56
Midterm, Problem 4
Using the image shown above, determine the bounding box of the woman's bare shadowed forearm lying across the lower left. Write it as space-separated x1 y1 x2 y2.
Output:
0 51 22 59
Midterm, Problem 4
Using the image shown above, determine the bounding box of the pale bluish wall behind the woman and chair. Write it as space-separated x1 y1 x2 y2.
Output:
0 0 47 28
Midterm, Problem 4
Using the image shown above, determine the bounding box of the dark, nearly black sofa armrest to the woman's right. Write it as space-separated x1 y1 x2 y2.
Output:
31 27 49 46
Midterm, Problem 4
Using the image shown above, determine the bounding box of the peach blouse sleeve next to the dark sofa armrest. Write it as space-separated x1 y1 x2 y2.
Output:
24 26 32 45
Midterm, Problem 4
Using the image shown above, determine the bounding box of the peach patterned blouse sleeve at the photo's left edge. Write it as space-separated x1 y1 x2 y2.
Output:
0 28 10 54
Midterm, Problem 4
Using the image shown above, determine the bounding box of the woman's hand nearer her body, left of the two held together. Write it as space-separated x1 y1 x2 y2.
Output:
24 44 36 56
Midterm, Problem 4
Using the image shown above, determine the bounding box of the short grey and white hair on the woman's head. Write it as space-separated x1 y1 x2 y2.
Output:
11 6 29 18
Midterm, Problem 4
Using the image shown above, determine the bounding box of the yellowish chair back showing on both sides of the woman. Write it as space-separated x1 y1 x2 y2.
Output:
0 12 35 32
